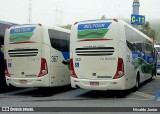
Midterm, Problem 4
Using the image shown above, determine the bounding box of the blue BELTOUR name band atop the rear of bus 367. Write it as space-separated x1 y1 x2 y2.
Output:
10 27 36 34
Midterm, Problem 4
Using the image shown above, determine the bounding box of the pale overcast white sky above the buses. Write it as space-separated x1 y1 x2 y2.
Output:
0 0 160 26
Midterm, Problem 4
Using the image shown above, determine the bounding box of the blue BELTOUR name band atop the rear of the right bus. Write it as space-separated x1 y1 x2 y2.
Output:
78 22 111 30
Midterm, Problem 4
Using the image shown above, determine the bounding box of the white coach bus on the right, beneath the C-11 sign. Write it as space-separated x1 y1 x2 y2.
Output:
70 19 155 90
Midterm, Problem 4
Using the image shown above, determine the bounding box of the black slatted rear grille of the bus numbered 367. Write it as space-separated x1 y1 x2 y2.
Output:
8 49 38 57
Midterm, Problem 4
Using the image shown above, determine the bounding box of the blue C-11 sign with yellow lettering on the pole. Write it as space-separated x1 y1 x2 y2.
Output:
131 14 145 25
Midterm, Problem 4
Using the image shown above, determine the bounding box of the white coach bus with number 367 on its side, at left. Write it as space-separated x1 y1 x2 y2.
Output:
4 24 70 87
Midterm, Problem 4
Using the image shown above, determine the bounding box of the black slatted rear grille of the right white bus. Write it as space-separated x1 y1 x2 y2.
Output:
76 47 114 56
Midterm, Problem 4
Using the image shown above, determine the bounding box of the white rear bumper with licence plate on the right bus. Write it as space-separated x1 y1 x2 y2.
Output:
71 76 126 90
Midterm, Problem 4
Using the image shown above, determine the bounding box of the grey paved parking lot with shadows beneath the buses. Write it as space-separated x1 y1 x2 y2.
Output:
0 76 160 114
